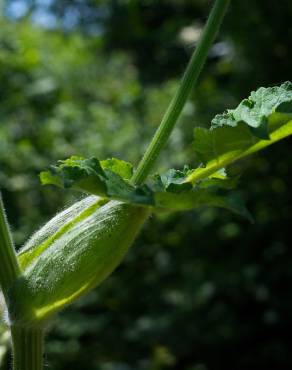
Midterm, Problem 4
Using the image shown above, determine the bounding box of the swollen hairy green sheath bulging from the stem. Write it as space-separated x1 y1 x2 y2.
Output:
10 197 150 325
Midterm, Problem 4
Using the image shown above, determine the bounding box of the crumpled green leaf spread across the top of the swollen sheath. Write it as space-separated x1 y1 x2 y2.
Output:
40 157 250 220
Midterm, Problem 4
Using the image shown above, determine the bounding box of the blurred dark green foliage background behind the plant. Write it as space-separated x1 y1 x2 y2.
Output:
0 0 292 370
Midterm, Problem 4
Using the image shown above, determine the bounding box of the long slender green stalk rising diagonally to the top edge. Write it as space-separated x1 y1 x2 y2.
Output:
132 0 230 185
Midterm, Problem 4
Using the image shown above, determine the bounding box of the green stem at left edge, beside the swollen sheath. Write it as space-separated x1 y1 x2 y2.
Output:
0 195 20 299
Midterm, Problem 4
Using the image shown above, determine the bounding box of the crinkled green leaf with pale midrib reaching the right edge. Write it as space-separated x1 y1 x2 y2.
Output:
187 82 292 182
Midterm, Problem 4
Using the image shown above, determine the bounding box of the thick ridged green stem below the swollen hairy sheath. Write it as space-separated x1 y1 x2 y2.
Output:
11 326 44 370
